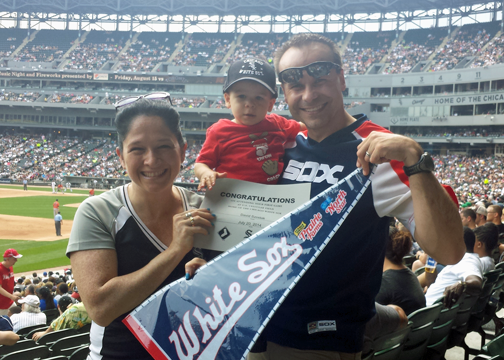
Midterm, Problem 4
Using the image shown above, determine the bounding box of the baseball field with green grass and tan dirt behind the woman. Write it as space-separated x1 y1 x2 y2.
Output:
0 185 105 274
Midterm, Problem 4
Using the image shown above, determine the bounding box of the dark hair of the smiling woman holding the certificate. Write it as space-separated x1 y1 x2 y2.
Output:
115 99 185 151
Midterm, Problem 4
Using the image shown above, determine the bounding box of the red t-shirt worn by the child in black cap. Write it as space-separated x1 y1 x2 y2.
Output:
196 114 300 184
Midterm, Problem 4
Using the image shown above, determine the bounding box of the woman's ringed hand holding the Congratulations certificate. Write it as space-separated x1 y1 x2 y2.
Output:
170 209 215 254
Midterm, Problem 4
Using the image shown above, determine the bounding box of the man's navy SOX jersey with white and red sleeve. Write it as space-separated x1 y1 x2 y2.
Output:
265 115 415 353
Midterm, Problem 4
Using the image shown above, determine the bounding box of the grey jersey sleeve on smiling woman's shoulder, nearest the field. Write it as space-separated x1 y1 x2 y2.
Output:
66 197 116 256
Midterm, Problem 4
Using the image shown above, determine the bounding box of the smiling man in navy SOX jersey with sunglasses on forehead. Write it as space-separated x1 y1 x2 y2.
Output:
251 34 464 359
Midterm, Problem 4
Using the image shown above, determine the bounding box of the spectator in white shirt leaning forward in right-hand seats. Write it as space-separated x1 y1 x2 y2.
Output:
425 227 483 306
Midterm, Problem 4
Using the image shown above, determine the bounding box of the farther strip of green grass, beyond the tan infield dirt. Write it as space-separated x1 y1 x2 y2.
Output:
0 196 87 221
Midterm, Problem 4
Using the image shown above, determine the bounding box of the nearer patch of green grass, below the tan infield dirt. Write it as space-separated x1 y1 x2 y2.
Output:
0 239 70 273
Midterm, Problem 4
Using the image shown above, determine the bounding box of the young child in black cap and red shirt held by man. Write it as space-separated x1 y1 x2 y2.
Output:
194 58 306 190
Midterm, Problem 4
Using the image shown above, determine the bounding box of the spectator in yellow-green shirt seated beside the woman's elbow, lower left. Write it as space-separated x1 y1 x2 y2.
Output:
32 296 91 341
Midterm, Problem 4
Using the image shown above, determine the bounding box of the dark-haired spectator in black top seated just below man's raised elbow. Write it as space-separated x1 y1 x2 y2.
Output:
376 227 425 315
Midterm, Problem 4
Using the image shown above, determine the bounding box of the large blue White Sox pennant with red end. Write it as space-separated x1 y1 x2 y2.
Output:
124 169 370 360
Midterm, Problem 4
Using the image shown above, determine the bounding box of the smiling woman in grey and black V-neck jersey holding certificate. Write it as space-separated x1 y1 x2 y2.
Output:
67 97 214 360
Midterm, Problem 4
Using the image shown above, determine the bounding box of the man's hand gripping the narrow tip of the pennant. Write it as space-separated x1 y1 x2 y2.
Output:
357 131 423 175
